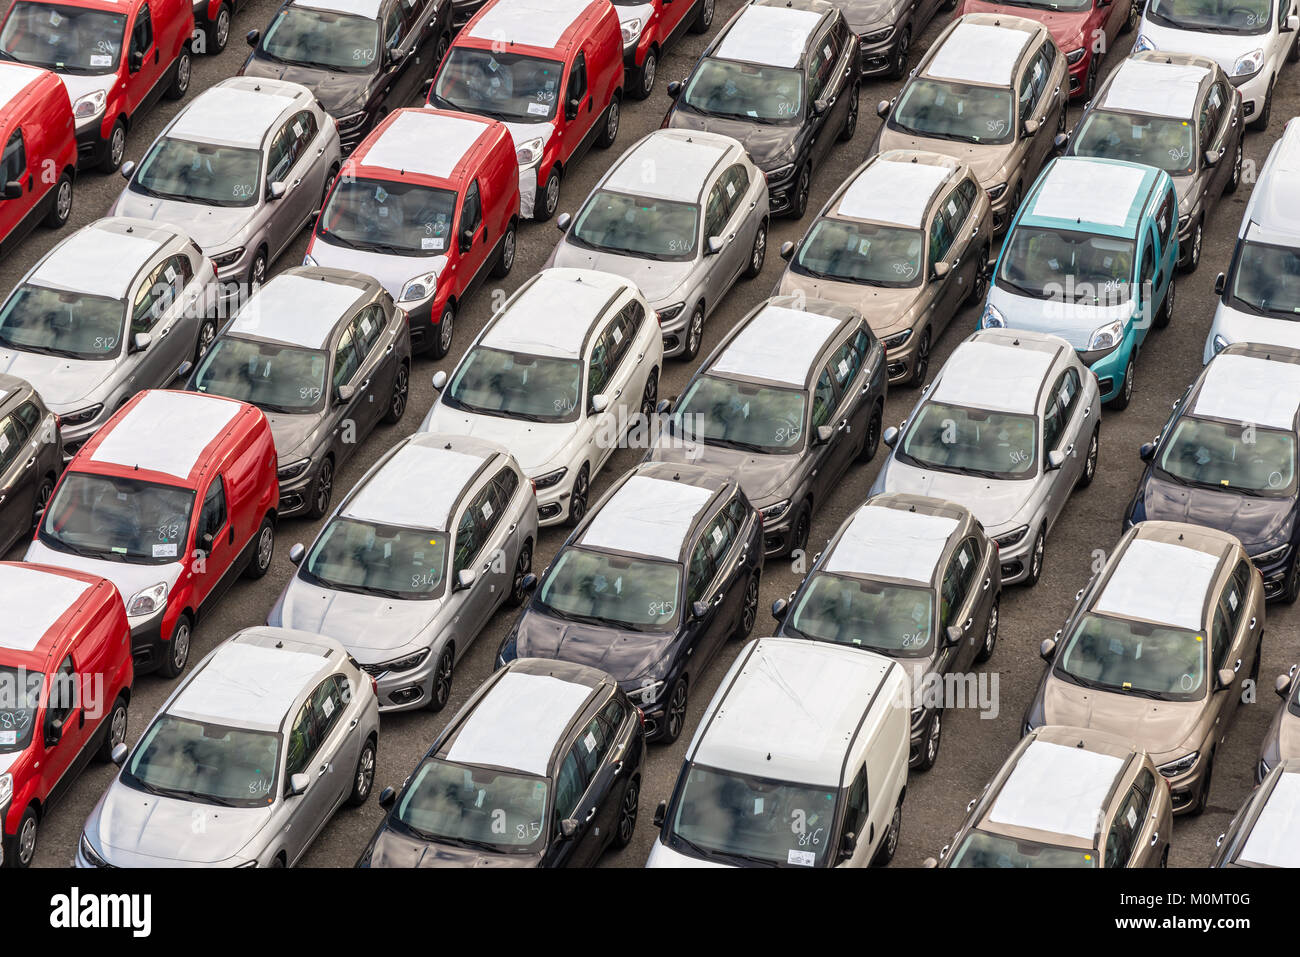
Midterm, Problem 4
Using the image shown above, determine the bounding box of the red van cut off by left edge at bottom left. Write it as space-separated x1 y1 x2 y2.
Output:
0 562 135 867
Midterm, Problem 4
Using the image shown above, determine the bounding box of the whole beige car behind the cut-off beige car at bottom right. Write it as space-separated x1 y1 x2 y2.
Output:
1024 521 1264 814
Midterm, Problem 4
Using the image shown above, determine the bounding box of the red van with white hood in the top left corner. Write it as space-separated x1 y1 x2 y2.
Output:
0 0 194 173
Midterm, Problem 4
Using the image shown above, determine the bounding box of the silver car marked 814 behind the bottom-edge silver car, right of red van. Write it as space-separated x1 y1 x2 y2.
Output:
267 432 537 711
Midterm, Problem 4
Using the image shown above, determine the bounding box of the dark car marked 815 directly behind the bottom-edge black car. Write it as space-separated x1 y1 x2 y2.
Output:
497 463 763 742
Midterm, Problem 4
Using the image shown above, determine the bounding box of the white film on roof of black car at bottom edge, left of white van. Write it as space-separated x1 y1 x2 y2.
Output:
447 671 592 775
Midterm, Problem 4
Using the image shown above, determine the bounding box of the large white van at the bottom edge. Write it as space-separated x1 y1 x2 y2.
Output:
646 638 911 867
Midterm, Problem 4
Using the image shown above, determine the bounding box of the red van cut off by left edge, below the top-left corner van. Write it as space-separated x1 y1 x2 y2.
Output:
0 62 77 256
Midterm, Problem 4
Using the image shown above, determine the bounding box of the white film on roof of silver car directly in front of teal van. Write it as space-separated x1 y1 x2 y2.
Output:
931 339 1053 413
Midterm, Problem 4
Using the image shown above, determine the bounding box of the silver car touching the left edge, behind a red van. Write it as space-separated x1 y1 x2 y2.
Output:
0 217 217 460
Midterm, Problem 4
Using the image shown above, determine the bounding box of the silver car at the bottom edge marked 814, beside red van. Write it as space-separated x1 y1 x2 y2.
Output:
74 627 380 867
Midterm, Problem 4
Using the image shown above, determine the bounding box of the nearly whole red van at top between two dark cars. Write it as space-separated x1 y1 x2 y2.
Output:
429 0 624 220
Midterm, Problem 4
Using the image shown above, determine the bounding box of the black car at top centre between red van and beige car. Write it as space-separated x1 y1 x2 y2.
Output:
663 0 861 220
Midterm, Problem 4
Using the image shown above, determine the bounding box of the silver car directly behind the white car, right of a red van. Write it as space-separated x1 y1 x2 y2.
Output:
546 130 768 360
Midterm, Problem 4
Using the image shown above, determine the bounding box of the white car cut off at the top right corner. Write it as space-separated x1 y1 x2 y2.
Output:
1134 0 1300 130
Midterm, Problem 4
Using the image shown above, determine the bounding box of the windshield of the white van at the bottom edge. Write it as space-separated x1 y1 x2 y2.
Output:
666 765 839 867
